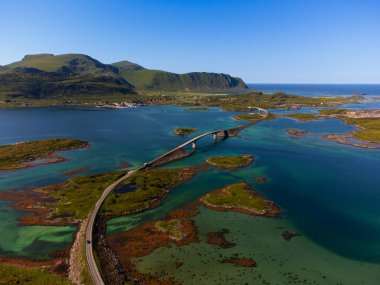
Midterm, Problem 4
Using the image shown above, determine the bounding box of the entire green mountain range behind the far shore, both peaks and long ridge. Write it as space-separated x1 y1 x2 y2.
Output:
0 54 247 99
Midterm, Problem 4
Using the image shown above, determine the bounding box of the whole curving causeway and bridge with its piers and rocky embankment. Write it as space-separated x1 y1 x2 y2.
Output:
85 107 269 285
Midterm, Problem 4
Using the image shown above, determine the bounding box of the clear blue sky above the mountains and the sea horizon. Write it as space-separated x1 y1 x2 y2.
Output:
0 0 380 83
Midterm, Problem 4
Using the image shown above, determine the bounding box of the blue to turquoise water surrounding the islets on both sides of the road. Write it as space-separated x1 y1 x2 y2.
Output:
0 106 380 285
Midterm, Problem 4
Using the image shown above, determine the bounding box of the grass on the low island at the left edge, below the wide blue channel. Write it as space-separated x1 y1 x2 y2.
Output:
0 139 87 170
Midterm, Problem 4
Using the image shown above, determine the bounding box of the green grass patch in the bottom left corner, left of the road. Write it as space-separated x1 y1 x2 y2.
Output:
0 264 72 285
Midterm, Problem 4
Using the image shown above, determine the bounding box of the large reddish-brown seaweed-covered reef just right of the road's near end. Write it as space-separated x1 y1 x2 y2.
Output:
101 204 198 285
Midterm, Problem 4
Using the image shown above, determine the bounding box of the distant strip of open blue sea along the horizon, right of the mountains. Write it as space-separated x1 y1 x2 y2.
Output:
247 83 380 97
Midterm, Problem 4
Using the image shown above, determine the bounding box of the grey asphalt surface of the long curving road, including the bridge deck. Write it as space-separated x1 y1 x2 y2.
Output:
85 107 268 285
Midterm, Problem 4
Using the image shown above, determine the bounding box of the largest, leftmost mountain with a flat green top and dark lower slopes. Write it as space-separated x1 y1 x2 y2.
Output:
0 54 134 99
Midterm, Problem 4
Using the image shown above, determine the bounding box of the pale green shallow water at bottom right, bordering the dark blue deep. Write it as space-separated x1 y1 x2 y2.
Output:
134 208 380 285
